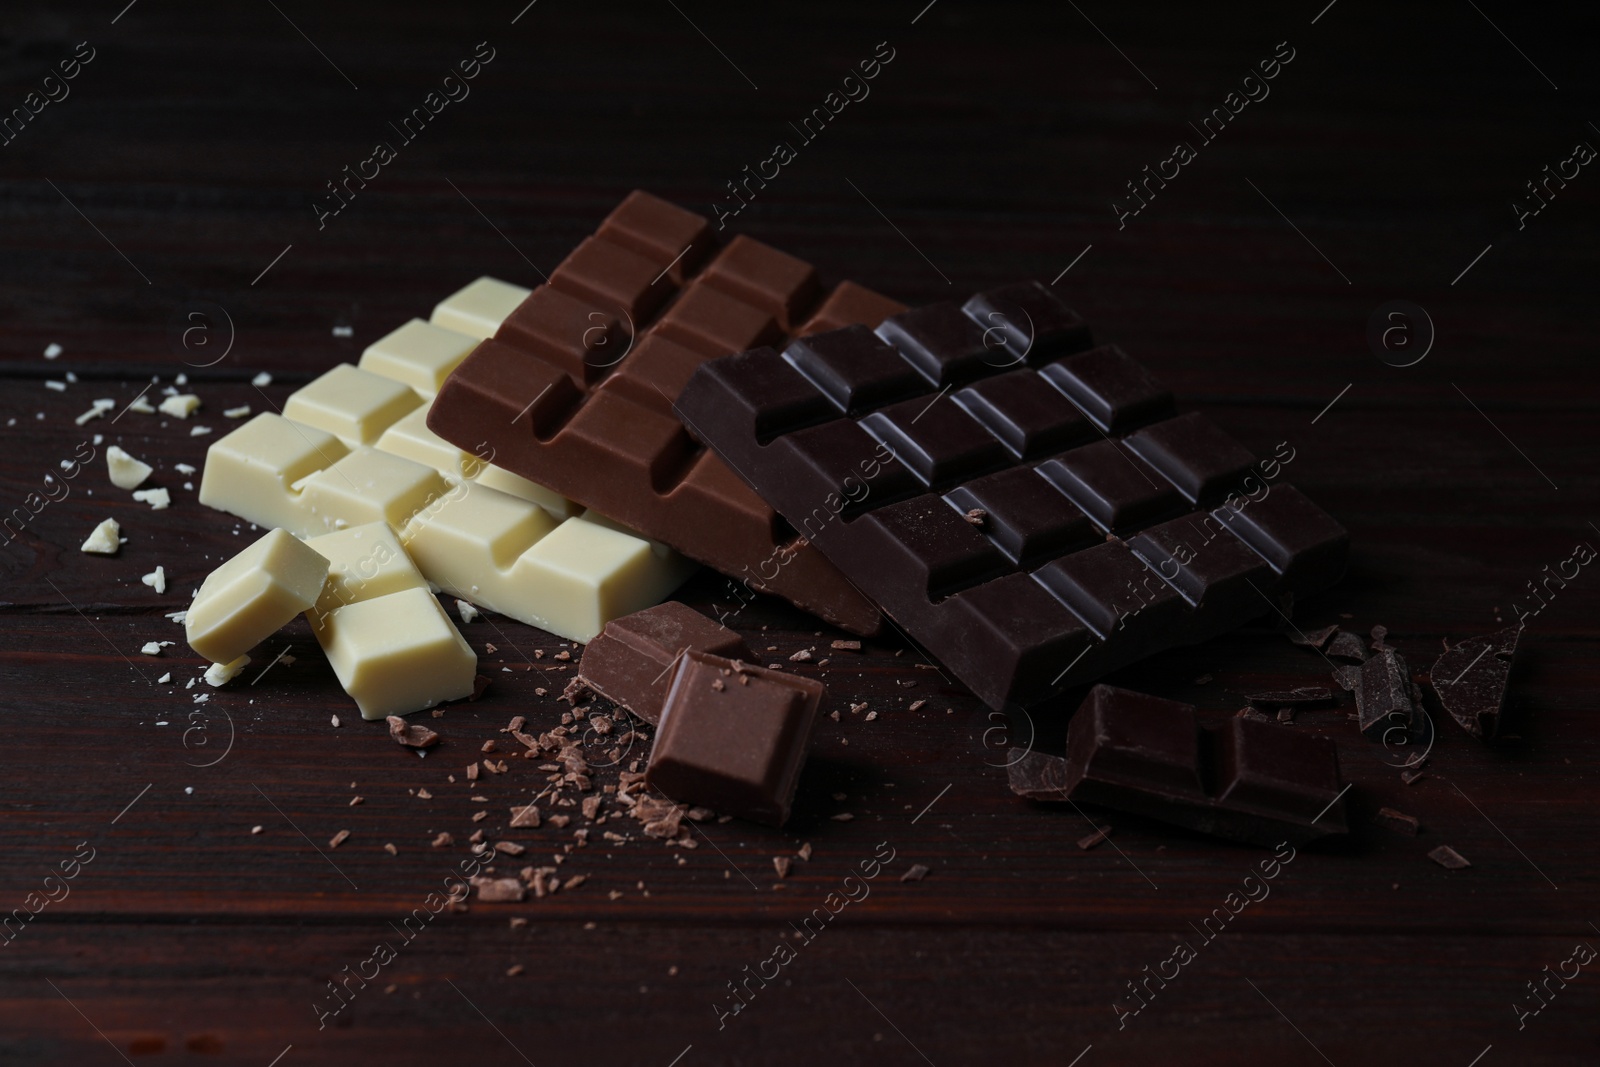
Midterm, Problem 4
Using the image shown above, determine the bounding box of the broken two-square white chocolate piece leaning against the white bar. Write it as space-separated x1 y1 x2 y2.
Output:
306 523 478 718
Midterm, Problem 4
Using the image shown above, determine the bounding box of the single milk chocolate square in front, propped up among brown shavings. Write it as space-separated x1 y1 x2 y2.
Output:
645 653 822 825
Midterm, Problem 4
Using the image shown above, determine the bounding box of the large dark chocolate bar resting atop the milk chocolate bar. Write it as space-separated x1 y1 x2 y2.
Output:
677 282 1349 709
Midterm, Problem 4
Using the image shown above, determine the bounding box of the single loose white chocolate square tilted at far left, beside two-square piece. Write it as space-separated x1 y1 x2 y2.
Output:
184 530 328 664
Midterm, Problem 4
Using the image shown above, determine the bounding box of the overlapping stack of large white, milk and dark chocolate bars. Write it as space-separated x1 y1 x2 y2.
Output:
203 192 1349 844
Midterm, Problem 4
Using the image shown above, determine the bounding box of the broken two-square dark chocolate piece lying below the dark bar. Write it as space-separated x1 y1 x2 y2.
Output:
1008 685 1347 846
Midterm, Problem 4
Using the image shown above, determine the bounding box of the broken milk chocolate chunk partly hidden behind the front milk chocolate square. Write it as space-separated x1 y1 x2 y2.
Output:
578 600 755 723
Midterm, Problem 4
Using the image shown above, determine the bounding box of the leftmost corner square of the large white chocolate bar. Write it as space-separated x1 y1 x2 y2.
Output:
200 411 349 536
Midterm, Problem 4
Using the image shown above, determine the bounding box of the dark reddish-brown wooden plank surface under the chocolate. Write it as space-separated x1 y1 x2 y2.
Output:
0 0 1600 1067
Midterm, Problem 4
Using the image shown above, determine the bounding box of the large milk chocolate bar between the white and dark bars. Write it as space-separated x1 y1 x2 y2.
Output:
427 192 904 633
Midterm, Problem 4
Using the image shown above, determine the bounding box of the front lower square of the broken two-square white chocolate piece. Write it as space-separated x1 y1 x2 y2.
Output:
314 589 478 718
